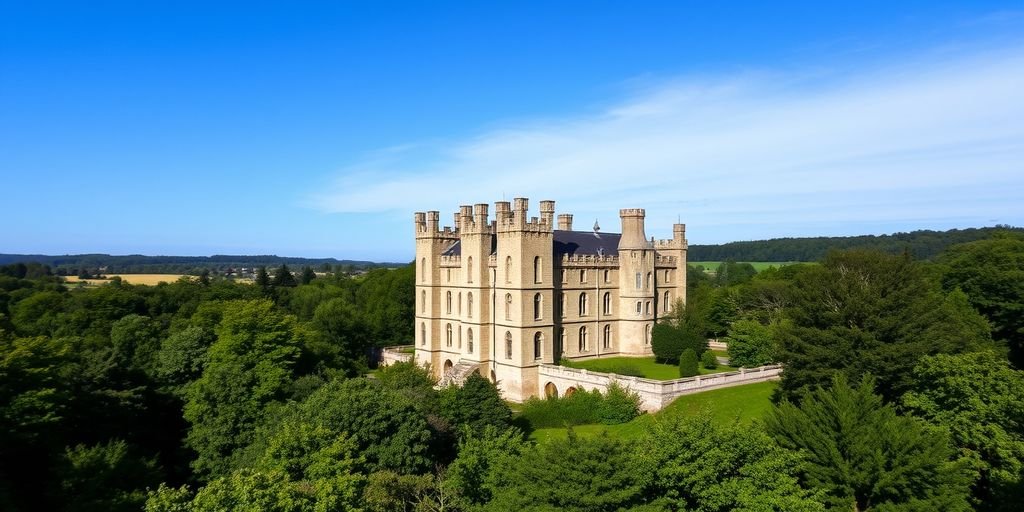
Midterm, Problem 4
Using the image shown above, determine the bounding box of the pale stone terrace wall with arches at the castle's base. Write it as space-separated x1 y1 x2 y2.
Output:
538 365 782 412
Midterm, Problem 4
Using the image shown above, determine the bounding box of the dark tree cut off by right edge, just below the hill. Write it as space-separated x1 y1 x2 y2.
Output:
940 232 1024 369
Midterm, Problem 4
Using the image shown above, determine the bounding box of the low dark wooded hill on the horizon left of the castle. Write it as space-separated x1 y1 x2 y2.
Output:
0 254 407 274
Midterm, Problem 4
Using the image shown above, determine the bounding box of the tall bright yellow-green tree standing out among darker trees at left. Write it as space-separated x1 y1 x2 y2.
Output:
184 300 301 476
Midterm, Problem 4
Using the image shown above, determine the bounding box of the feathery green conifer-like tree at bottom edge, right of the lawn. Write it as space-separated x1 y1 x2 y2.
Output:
764 374 971 511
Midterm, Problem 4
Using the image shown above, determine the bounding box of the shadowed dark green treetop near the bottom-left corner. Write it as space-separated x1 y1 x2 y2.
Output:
59 440 160 512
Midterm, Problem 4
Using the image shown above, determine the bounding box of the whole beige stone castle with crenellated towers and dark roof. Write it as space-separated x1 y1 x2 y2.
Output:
415 198 687 401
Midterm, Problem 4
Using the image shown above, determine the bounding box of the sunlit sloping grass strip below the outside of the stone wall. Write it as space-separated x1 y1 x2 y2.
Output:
529 381 778 442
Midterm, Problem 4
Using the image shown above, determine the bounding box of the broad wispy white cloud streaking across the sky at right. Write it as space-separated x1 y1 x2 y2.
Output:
310 46 1024 241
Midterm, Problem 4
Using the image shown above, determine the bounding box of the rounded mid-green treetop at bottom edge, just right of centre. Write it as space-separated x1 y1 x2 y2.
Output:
482 435 650 512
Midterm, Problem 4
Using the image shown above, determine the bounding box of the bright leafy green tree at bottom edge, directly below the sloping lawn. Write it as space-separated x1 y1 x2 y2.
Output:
640 416 824 512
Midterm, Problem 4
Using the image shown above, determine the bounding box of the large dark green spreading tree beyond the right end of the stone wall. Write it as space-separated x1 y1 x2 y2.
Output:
779 252 991 401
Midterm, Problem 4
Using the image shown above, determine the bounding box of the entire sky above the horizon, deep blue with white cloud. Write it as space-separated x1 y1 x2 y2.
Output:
0 1 1024 261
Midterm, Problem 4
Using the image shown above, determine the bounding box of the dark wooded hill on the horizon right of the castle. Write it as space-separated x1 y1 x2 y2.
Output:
686 225 1024 261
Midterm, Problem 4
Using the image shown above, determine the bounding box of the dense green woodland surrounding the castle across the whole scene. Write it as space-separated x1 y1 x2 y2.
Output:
0 231 1024 512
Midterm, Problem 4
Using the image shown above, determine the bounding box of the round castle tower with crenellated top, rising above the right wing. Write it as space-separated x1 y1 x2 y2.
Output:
618 208 656 355
